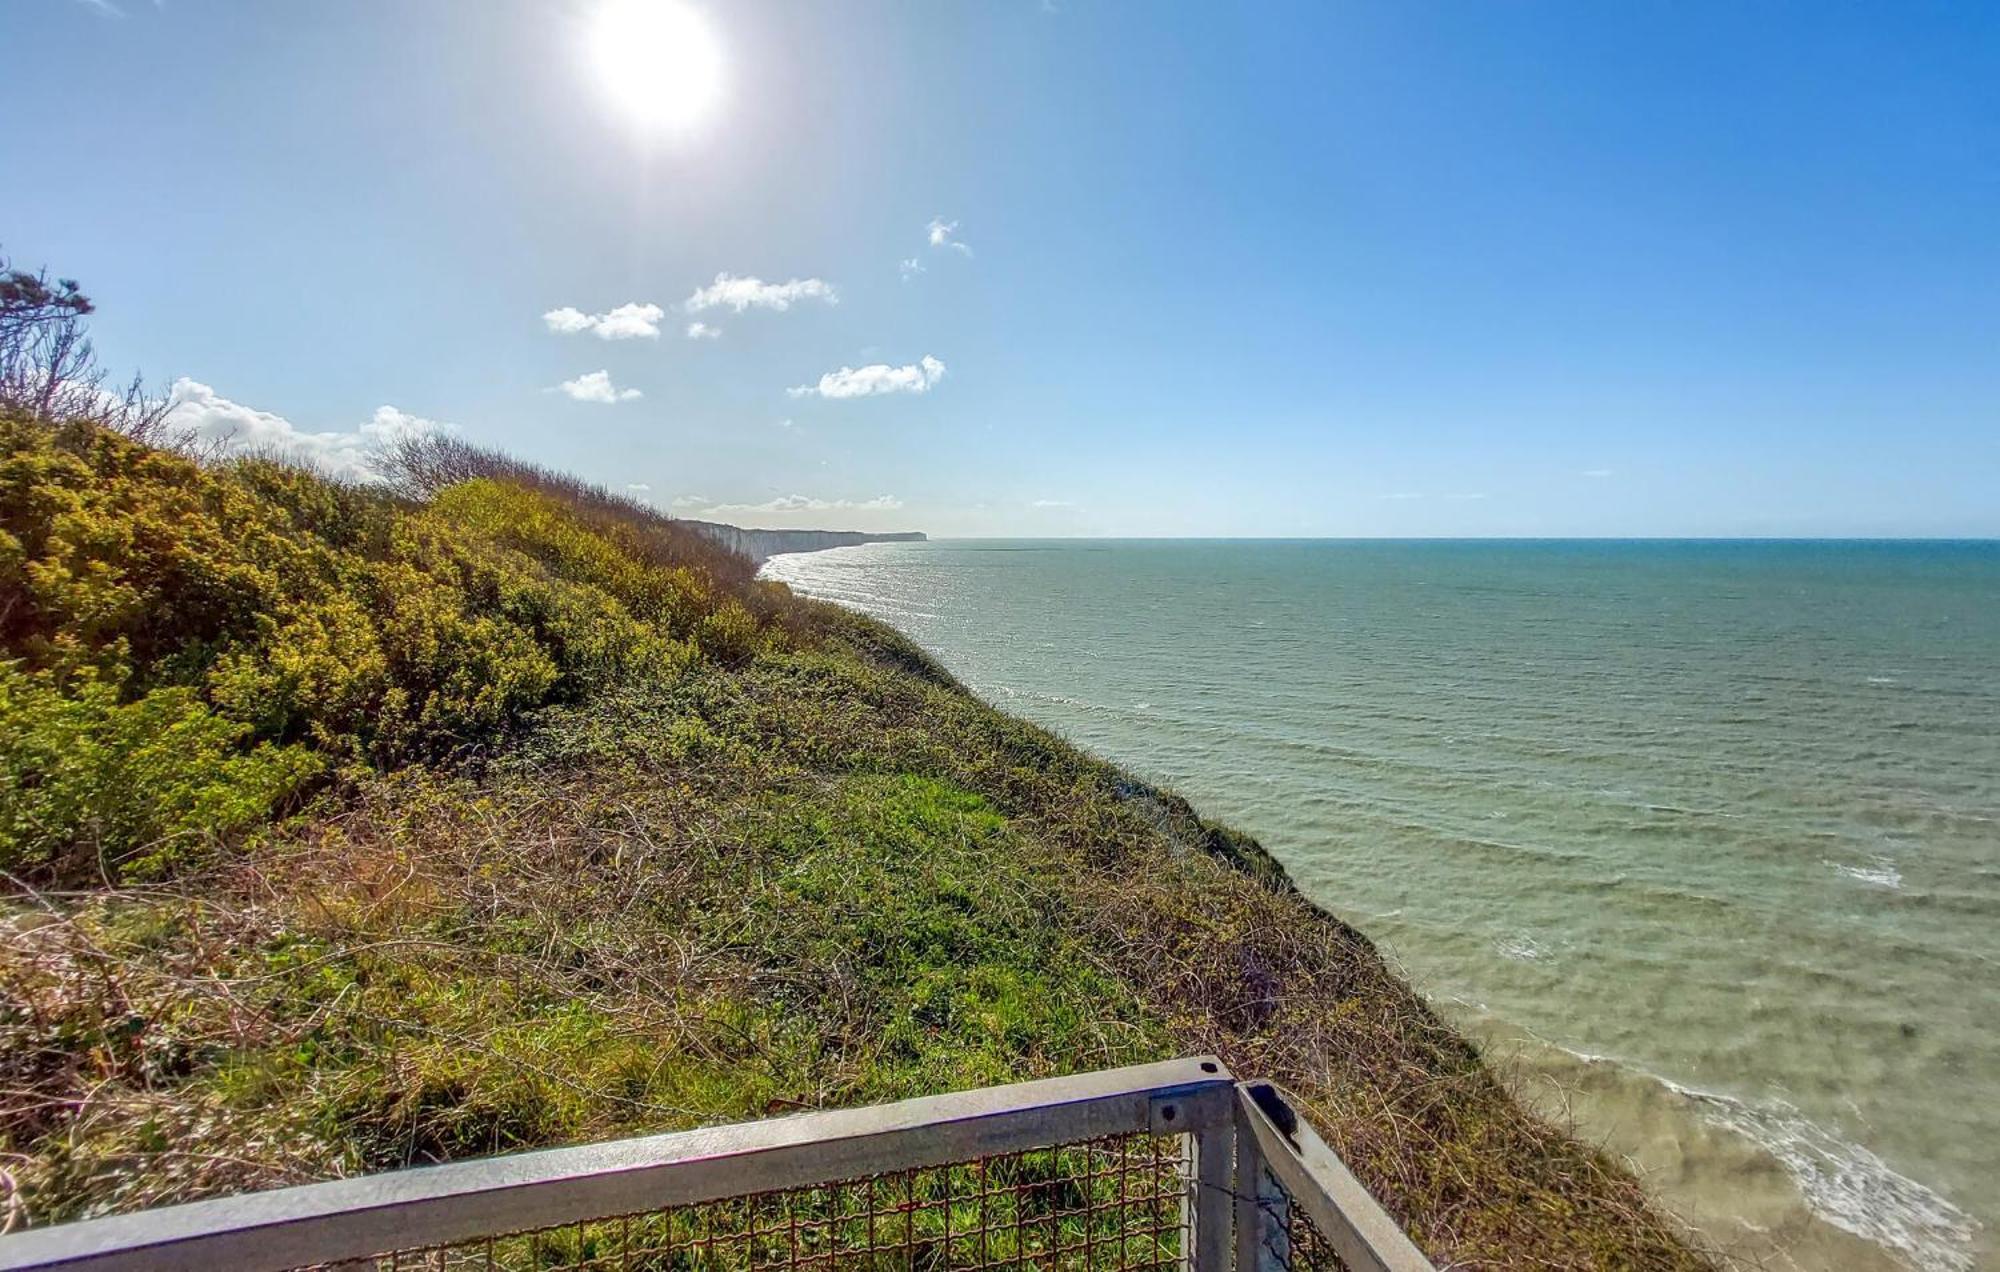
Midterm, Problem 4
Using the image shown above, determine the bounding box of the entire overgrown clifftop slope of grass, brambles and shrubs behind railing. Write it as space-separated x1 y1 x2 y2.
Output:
0 422 1700 1268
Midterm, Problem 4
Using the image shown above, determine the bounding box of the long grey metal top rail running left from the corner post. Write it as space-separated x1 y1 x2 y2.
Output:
0 1056 1236 1272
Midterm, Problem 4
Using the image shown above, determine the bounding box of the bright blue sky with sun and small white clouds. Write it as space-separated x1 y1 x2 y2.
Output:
0 0 2000 536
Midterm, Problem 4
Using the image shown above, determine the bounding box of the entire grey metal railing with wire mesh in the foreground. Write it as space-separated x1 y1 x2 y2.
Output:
0 1058 1430 1272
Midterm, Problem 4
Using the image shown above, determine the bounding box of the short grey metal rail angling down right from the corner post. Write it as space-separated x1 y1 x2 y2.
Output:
1236 1082 1436 1272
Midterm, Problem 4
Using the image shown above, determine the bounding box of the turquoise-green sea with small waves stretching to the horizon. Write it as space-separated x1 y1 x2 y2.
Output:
766 540 2000 1268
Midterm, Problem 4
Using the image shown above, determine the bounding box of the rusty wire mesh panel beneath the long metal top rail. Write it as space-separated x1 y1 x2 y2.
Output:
314 1134 1192 1272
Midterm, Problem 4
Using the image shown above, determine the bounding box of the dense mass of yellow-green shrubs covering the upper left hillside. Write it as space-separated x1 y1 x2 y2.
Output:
0 414 728 864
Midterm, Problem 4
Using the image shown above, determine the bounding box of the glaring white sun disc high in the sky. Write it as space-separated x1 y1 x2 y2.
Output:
590 0 722 130
